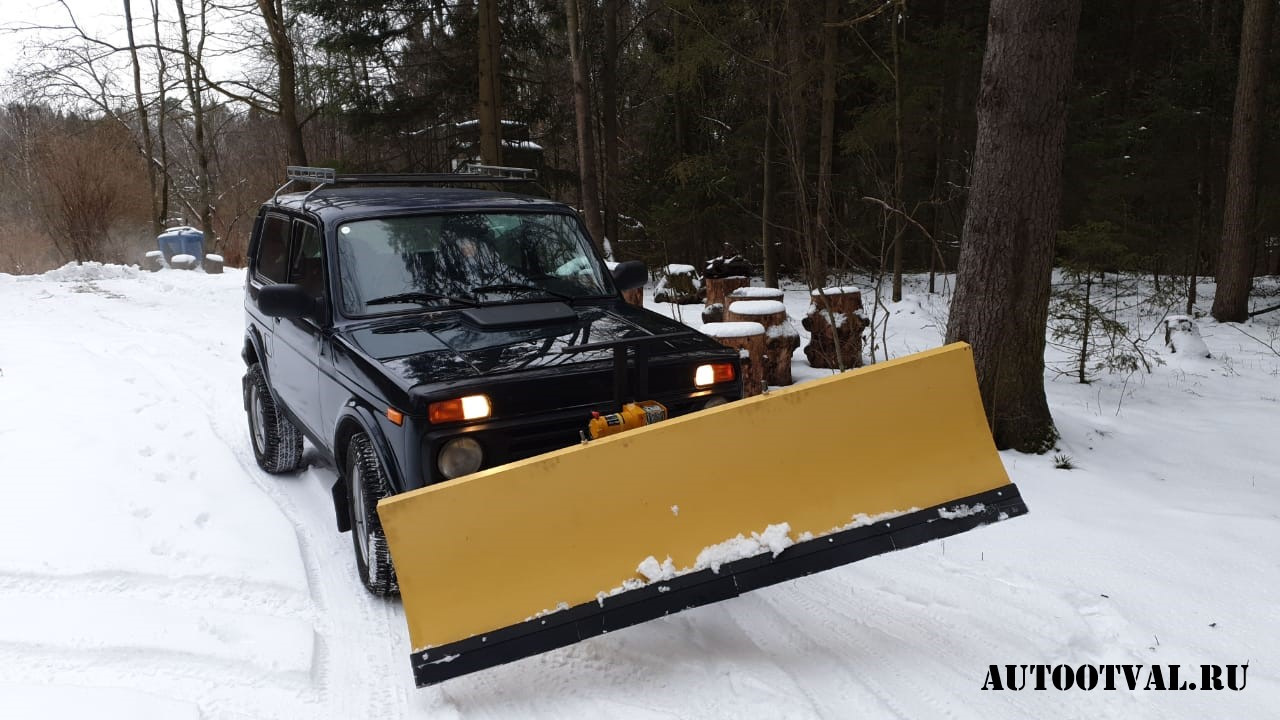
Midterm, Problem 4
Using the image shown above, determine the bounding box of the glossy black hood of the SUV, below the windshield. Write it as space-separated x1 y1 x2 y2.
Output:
342 304 705 388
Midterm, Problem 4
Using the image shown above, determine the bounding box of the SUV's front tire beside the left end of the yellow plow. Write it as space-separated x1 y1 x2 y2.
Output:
346 433 399 597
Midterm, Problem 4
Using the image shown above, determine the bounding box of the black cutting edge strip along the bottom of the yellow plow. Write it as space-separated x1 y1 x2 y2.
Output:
410 483 1027 687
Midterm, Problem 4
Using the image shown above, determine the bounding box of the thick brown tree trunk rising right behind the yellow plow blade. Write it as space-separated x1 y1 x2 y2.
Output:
947 0 1080 452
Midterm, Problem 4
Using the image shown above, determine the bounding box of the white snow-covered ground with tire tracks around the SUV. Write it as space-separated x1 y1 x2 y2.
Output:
0 265 1280 720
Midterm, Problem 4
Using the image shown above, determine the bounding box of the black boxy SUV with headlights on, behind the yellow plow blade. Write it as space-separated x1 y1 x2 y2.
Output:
243 168 741 594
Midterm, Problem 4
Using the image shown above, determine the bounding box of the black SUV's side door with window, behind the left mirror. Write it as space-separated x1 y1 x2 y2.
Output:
264 218 324 438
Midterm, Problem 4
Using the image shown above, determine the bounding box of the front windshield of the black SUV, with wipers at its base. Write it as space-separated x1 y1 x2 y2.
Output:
338 213 612 315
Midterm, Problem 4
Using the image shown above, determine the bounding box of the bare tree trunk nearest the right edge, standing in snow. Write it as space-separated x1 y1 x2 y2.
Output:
1213 0 1275 323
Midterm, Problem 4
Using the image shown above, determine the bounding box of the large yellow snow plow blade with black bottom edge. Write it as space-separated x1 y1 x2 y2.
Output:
378 343 1027 687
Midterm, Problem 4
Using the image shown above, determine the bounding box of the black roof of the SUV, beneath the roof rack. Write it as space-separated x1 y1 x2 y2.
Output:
269 186 568 220
